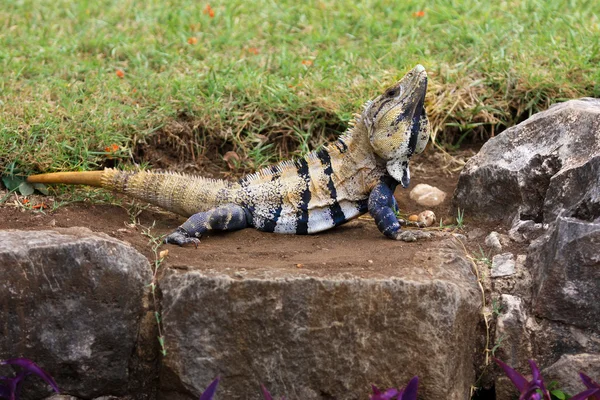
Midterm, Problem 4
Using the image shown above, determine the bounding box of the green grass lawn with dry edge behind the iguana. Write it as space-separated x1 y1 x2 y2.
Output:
0 0 600 173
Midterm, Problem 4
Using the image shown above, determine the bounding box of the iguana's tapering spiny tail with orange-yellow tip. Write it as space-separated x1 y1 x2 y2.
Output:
27 168 237 216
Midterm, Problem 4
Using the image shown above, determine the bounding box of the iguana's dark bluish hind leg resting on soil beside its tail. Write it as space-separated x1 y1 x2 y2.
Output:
165 204 250 247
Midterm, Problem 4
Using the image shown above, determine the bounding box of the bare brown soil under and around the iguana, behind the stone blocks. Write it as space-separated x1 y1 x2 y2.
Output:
0 150 509 277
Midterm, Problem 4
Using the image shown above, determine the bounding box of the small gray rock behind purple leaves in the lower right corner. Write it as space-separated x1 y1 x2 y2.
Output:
542 353 600 396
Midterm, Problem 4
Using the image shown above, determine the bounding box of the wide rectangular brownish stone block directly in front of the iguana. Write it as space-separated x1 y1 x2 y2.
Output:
160 242 481 400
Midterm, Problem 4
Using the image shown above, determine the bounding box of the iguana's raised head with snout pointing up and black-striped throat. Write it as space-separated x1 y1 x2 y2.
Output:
362 65 429 187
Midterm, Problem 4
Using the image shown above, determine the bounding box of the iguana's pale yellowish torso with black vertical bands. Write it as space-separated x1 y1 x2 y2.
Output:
235 136 385 235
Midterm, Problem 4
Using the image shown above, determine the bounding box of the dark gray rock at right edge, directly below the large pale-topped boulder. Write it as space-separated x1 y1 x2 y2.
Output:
528 217 600 332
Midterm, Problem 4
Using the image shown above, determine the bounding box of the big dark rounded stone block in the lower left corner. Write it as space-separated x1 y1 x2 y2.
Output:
0 228 153 398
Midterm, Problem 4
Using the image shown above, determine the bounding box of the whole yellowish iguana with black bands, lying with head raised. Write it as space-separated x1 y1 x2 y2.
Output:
27 65 429 246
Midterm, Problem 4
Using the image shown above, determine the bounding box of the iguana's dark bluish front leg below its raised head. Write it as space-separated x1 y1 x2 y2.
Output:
369 181 430 242
